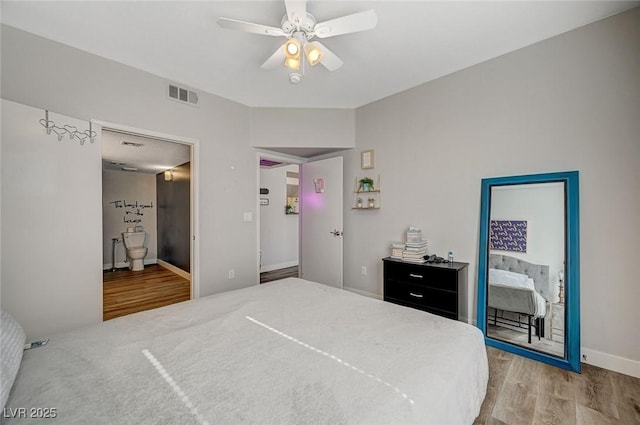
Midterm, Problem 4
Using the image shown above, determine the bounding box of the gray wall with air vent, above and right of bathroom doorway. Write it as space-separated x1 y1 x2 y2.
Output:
1 25 258 302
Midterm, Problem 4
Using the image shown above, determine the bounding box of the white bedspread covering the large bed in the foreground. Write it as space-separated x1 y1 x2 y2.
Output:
2 279 488 425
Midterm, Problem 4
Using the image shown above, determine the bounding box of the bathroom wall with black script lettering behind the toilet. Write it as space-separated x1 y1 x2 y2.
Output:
102 170 157 269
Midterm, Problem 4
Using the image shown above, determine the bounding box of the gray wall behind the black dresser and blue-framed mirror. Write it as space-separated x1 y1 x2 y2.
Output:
344 8 640 373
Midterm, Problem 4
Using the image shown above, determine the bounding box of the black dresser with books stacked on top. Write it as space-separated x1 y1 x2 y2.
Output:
382 257 469 321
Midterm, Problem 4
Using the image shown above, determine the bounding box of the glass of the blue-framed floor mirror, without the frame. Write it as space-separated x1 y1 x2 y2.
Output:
486 182 565 358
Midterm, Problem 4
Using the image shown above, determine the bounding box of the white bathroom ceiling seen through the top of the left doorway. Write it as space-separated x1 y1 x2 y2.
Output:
102 130 191 174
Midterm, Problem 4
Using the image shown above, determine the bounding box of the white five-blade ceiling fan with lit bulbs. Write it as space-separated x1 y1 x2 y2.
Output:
218 0 378 84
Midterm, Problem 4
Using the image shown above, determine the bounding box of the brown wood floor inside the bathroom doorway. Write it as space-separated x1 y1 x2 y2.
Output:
102 264 191 320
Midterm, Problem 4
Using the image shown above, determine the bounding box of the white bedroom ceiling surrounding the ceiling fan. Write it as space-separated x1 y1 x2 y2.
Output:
1 0 640 108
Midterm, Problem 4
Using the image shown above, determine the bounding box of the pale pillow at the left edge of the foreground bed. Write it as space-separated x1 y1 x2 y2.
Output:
0 310 27 409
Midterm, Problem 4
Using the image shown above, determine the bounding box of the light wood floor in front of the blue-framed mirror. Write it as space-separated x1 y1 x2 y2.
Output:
474 347 640 425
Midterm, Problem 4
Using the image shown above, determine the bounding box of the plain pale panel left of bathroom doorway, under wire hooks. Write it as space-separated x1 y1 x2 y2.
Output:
0 99 102 340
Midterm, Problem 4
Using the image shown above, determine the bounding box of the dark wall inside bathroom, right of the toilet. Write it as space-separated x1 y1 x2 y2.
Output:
155 162 191 272
